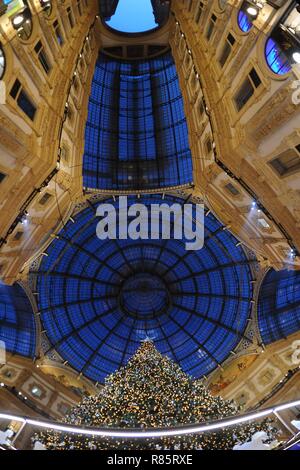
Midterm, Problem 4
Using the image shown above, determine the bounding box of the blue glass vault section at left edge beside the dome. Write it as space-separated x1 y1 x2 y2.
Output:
0 283 36 357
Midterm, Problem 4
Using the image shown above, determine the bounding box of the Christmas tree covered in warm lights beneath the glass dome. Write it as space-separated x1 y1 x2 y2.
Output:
37 341 275 450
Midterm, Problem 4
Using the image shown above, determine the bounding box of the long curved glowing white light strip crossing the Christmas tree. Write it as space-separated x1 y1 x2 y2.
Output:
0 400 300 439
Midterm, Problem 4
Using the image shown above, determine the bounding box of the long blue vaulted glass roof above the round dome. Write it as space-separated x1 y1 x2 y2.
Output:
83 53 193 190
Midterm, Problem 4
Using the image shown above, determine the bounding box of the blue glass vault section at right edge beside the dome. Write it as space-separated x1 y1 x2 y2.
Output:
258 269 300 344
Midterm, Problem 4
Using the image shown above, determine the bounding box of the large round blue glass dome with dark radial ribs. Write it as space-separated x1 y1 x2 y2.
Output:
36 195 252 382
